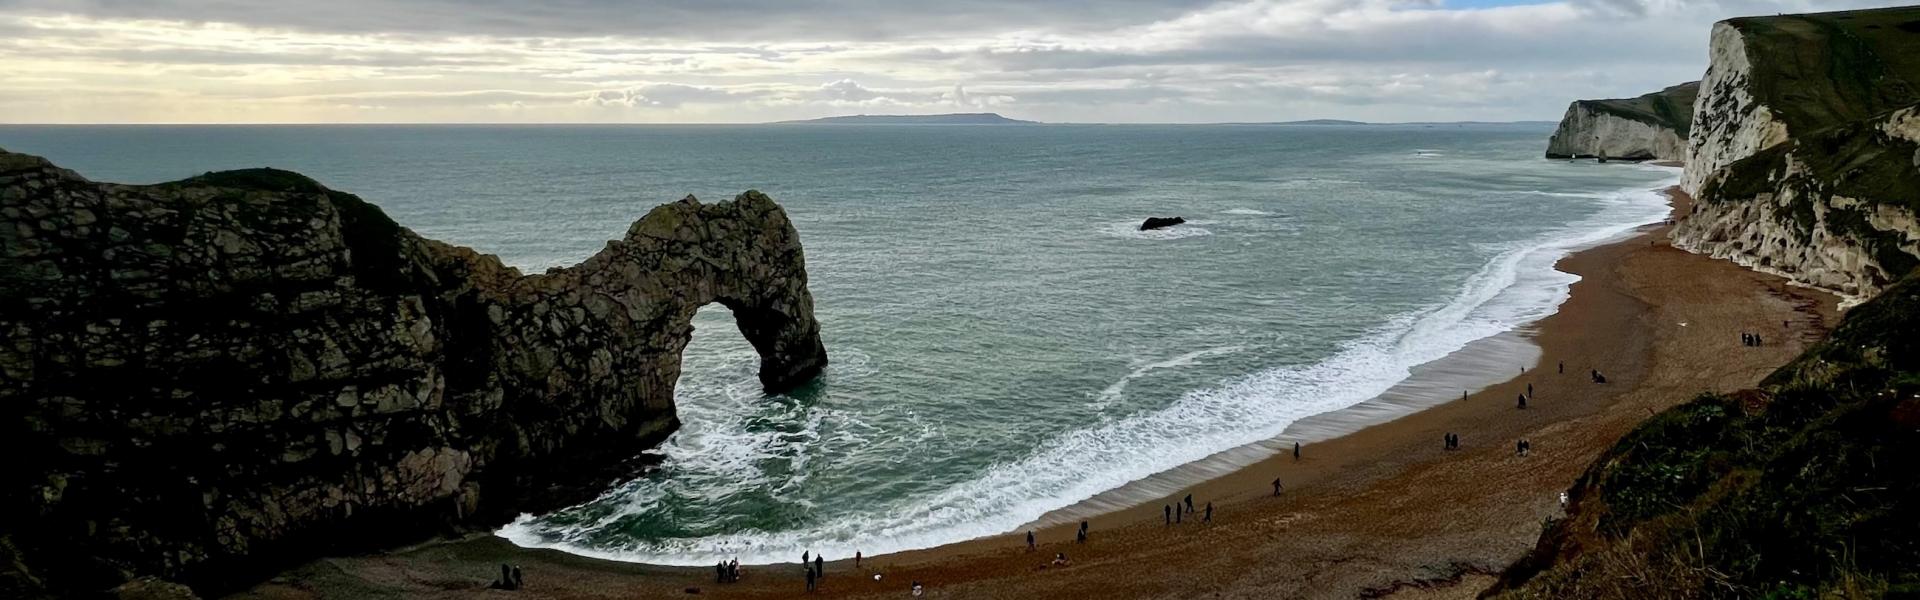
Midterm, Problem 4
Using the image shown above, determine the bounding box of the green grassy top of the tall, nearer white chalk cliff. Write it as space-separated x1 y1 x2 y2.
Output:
1728 6 1920 133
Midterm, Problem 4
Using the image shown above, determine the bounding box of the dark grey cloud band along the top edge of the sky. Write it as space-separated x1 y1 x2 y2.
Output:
0 0 1213 42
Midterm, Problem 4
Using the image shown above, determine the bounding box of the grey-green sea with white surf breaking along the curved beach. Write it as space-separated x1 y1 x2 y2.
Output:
0 123 1678 565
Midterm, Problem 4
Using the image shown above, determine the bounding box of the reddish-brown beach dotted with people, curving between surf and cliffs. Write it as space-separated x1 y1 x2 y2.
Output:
234 187 1837 600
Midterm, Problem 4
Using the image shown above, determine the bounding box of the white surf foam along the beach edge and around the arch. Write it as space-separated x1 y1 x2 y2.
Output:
499 167 1678 565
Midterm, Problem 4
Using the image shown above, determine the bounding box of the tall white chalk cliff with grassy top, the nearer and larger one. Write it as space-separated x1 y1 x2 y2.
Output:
1672 8 1920 302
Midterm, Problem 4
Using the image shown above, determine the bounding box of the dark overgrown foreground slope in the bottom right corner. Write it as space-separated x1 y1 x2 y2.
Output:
1484 277 1920 600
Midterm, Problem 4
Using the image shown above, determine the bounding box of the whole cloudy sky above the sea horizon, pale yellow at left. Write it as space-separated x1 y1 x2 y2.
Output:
0 0 1910 123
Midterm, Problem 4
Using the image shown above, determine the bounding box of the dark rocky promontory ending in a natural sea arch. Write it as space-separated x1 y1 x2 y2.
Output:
0 152 826 596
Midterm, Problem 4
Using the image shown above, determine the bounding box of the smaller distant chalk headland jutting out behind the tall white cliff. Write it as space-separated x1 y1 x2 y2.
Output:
1548 81 1699 160
